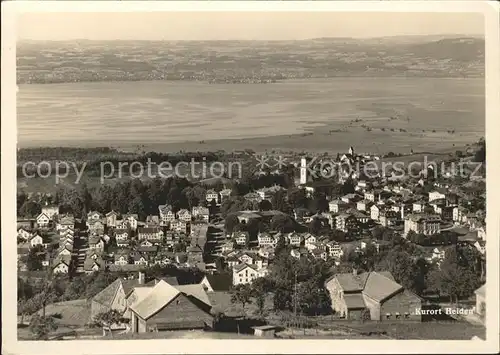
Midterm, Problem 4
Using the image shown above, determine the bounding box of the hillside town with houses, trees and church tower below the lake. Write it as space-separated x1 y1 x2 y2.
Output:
17 140 486 339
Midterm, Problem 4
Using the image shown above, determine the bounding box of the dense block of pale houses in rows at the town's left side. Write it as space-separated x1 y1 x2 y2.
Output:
17 200 210 273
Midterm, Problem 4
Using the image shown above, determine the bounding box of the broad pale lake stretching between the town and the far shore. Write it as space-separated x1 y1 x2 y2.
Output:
17 78 485 150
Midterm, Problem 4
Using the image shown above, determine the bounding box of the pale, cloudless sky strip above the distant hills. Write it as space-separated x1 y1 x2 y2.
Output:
17 12 484 40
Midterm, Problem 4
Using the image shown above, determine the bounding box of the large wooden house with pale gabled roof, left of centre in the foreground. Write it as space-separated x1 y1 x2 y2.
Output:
128 280 213 333
